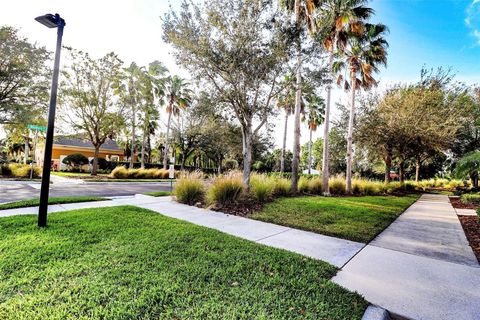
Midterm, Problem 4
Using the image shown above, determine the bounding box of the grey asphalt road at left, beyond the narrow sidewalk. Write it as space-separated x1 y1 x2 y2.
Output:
0 182 170 203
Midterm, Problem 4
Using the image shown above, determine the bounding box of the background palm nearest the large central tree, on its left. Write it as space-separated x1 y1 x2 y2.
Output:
163 75 192 169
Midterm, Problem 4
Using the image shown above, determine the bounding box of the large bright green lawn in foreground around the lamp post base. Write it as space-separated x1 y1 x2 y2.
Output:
0 206 367 319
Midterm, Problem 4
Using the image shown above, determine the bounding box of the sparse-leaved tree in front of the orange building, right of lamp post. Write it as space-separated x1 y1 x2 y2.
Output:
61 49 124 175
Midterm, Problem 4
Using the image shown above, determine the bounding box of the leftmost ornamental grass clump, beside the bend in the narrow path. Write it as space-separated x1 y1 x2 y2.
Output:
173 172 205 205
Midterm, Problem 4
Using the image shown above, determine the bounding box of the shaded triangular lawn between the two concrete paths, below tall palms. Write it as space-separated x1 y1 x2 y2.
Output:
251 195 418 243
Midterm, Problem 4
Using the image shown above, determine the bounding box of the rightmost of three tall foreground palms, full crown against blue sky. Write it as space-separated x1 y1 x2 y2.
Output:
333 23 388 193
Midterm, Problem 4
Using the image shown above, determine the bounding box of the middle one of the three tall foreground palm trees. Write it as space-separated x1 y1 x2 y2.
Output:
319 0 373 195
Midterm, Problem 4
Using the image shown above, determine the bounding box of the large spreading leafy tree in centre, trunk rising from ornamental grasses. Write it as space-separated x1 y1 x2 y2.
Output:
163 0 290 190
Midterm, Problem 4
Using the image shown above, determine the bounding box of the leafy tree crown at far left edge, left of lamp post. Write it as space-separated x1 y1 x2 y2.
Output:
0 26 50 125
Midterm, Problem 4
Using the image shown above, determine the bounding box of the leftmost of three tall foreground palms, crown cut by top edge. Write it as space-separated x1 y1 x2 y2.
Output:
280 0 322 192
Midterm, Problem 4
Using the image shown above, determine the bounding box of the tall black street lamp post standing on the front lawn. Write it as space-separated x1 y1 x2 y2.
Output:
35 14 65 227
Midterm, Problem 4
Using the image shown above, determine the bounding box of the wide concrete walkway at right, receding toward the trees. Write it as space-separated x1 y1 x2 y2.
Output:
333 195 480 320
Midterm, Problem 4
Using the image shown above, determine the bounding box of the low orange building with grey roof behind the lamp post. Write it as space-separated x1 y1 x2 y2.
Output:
35 135 125 170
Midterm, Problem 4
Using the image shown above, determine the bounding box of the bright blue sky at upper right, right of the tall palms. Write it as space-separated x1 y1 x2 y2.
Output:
371 0 480 83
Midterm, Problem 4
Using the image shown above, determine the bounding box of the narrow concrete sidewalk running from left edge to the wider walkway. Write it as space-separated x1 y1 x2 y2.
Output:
0 195 364 267
